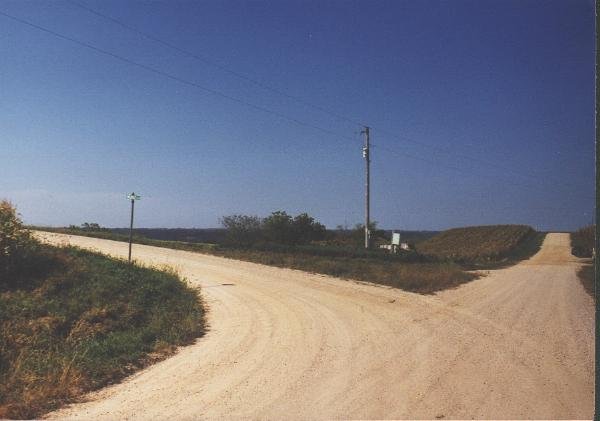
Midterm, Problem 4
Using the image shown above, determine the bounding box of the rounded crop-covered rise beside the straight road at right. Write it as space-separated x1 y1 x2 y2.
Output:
417 225 545 268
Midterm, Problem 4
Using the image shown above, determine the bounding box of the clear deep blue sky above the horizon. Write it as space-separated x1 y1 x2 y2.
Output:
0 0 595 230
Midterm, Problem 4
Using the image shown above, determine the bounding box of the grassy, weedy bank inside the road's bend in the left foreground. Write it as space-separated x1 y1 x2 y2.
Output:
0 201 204 418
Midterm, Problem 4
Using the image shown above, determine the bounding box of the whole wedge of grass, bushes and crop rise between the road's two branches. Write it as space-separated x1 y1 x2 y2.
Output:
35 211 543 294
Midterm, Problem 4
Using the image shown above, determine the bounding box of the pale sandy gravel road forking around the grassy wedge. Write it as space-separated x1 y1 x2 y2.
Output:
40 234 594 420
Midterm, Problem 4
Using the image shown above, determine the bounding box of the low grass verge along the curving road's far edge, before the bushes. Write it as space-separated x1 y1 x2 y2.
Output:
34 228 478 294
